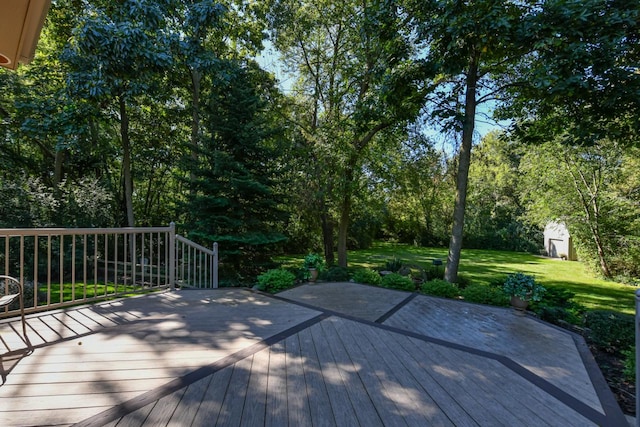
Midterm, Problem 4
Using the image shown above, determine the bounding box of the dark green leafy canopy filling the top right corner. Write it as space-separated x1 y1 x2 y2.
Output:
501 0 640 145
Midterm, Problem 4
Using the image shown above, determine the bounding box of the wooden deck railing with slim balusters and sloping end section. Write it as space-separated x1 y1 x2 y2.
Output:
0 223 218 317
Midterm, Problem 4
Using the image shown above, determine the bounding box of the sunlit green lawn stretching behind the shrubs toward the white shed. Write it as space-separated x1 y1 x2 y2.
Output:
308 243 636 314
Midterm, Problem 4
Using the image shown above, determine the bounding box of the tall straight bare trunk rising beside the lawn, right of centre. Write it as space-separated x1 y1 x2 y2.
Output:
444 55 478 283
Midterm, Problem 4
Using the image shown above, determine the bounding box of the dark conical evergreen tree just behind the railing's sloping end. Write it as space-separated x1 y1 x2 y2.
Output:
187 64 285 275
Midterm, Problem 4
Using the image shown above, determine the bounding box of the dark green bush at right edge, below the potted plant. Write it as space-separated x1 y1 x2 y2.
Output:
584 310 635 353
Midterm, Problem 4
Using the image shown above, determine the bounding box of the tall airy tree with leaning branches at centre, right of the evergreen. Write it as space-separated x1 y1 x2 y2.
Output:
271 0 420 267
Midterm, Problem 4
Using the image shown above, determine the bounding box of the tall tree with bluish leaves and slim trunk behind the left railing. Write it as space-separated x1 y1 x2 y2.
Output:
63 0 172 226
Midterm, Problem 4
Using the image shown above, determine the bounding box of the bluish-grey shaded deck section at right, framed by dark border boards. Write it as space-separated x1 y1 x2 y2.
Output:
385 296 602 410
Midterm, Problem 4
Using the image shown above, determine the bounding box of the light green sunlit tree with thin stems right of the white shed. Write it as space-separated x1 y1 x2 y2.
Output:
519 138 640 277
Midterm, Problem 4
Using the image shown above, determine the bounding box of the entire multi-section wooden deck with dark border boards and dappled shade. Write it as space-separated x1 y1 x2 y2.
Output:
0 283 625 427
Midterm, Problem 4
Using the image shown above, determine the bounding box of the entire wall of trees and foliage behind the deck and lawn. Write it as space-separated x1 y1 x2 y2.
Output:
0 0 640 291
